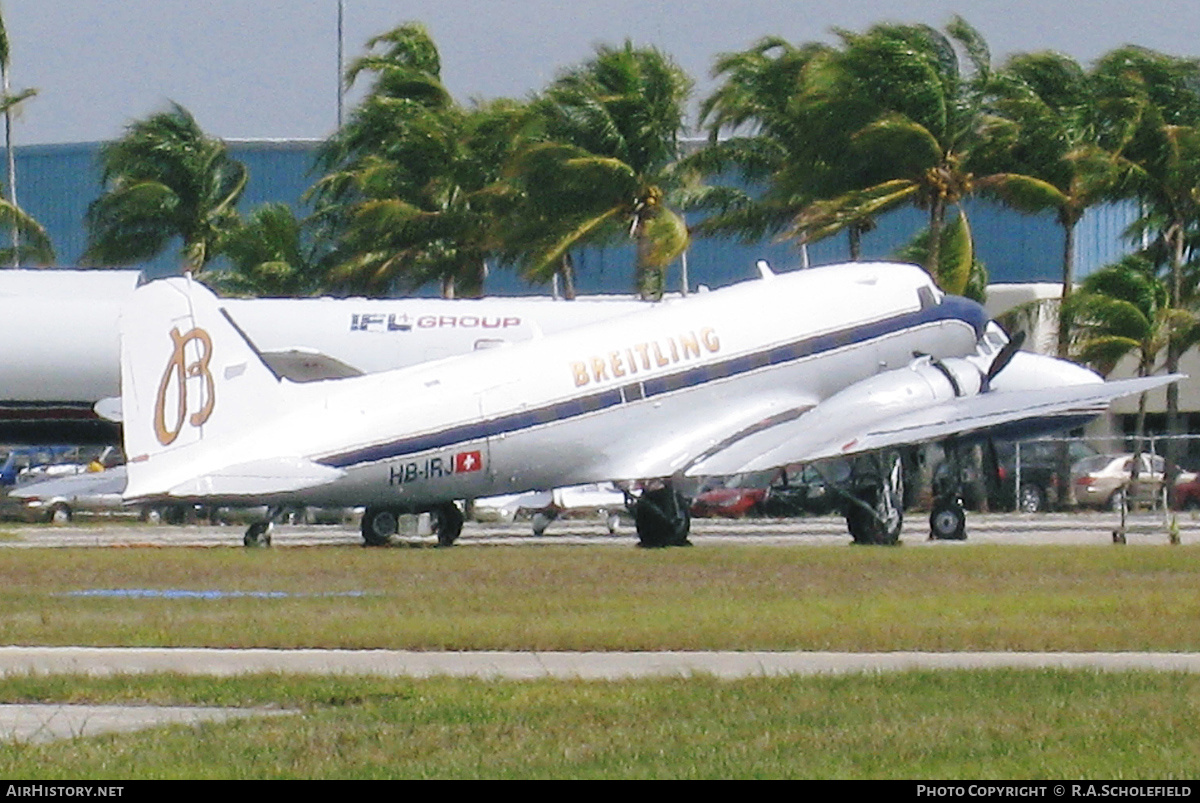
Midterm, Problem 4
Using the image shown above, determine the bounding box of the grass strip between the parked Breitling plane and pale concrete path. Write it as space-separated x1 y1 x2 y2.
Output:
0 545 1200 651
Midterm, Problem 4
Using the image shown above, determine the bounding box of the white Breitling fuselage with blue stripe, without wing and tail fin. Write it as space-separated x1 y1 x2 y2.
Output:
127 264 986 507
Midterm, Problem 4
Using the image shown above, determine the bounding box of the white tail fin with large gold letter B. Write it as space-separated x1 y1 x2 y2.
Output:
120 277 300 497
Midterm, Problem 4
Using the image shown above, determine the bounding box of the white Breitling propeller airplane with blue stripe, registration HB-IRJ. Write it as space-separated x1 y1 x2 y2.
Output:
121 263 1180 546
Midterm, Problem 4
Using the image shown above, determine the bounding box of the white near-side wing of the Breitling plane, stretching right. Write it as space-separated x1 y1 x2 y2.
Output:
685 374 1183 477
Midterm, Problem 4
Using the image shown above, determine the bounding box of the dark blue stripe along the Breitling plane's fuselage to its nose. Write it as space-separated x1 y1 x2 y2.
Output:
318 295 989 468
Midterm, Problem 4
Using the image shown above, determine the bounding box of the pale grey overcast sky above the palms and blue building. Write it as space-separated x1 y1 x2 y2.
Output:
0 0 1200 145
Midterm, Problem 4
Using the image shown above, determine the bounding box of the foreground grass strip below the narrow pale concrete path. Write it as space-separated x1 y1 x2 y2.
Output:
0 670 1200 781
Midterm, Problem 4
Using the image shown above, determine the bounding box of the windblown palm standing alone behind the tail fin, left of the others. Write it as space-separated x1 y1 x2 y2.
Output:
84 103 247 274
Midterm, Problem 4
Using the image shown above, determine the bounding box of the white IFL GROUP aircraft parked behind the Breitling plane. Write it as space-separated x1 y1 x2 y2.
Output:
0 270 642 444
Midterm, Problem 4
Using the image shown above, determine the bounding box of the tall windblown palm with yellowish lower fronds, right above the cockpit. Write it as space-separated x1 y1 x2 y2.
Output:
793 17 1022 293
